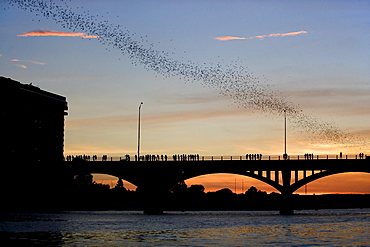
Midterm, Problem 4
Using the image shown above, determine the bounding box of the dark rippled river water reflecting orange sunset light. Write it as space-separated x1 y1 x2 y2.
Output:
0 209 370 246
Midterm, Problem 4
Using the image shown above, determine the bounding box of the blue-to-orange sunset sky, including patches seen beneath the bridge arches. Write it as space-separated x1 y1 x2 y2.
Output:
0 0 370 193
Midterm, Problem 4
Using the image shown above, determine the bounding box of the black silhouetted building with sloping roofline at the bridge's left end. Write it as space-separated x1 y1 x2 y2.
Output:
0 77 68 162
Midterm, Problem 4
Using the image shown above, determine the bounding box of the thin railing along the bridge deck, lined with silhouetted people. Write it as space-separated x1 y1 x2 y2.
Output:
65 154 370 162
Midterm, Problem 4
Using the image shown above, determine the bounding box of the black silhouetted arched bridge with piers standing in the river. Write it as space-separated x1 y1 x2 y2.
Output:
67 157 370 214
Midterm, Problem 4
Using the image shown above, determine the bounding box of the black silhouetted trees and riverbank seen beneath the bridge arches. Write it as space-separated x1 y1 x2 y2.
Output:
1 169 370 212
